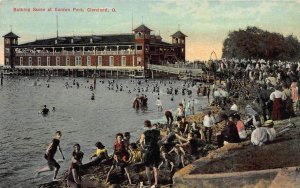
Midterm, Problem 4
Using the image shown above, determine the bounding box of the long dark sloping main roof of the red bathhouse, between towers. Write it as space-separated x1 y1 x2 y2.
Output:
19 34 134 47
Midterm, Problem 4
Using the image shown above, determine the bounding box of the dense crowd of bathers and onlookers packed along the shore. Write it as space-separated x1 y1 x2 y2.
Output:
31 60 300 187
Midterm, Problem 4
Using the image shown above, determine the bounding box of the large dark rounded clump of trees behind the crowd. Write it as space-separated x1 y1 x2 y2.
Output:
222 27 300 60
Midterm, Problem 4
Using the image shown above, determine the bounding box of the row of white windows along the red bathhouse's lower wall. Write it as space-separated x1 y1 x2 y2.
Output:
20 56 134 66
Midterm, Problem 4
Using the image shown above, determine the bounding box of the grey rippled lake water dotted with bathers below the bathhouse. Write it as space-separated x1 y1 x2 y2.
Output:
0 77 207 187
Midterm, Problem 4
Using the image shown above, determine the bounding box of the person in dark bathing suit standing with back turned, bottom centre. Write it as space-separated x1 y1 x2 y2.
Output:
140 120 160 186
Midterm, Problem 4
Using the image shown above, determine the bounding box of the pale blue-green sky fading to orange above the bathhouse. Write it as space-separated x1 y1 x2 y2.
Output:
0 0 300 64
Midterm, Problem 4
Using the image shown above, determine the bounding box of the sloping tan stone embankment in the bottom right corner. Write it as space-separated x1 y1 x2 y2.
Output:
173 117 300 188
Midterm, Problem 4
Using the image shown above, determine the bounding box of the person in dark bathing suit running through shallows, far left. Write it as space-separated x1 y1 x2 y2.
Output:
36 131 65 181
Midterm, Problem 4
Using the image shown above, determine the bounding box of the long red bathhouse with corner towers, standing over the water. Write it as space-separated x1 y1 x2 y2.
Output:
3 25 186 75
